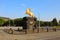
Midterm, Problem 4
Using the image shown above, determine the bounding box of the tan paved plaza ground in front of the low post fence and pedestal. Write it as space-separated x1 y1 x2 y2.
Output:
0 30 60 40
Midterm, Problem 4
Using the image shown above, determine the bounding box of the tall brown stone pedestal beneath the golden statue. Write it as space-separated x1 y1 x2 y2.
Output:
23 17 36 33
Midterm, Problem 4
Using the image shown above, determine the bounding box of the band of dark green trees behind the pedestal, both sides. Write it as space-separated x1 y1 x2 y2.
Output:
0 18 60 27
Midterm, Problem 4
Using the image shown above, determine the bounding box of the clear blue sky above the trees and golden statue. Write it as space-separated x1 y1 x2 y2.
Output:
0 0 60 21
